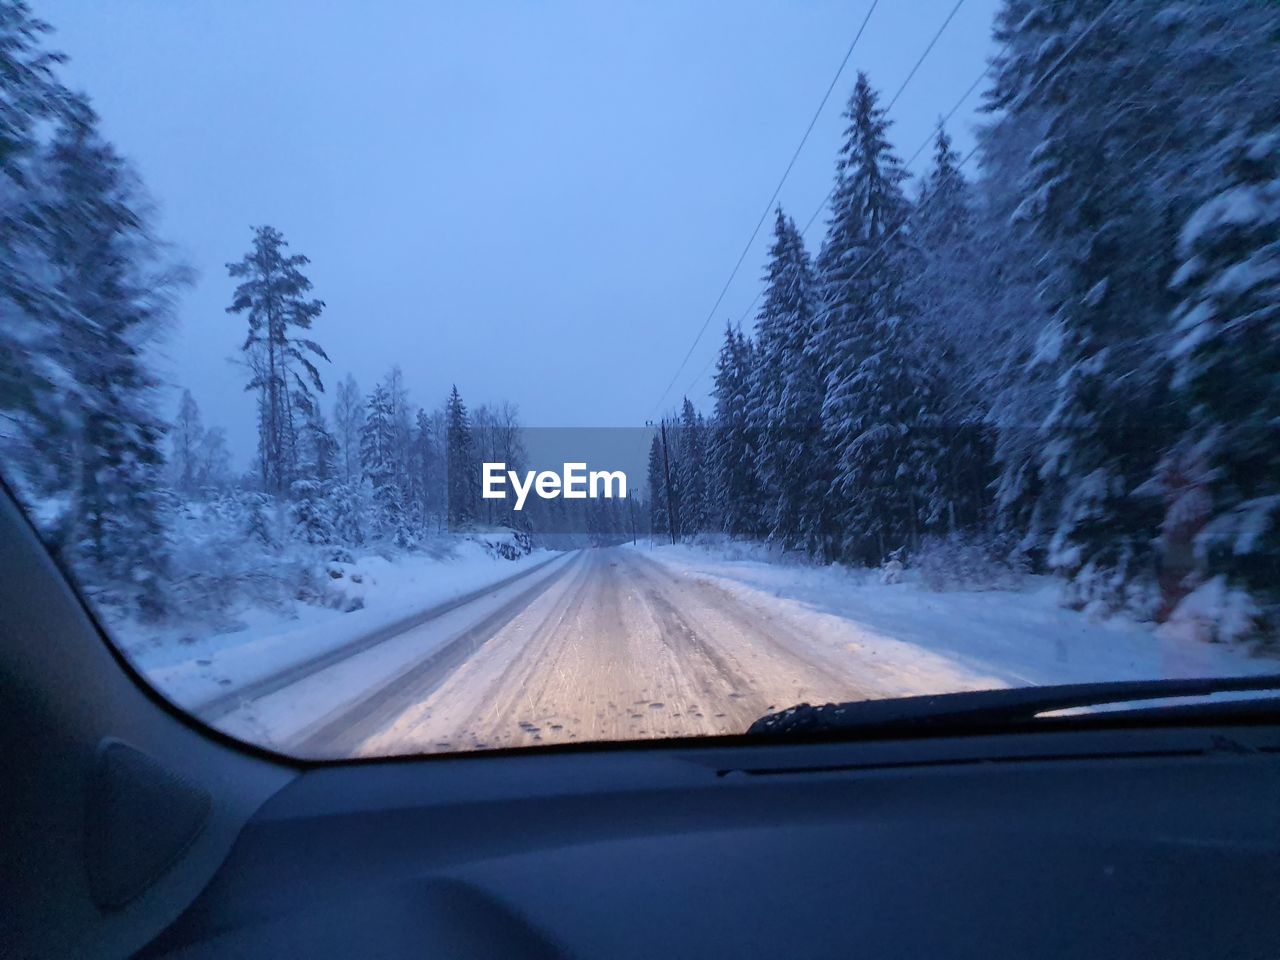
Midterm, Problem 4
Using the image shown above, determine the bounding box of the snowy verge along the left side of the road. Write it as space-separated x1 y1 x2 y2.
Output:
113 539 554 708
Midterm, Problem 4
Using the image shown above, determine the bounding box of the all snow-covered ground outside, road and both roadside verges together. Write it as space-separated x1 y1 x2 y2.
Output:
102 540 1280 756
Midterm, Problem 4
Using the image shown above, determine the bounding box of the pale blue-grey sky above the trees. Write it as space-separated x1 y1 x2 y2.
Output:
35 0 997 467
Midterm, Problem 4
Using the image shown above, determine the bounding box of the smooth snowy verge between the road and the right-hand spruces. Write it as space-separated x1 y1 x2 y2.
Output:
637 544 1280 695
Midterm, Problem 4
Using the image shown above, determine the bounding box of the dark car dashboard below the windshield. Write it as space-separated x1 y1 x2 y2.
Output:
141 726 1280 960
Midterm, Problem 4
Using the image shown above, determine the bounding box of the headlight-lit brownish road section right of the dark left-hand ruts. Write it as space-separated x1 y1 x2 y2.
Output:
345 549 877 755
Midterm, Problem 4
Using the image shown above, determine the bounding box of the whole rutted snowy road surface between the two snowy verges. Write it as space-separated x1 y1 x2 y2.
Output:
209 549 874 756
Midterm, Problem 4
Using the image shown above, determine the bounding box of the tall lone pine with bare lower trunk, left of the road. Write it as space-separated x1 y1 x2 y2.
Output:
227 227 329 493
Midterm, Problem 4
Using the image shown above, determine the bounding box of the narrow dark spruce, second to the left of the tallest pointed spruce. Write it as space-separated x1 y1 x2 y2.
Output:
707 324 760 538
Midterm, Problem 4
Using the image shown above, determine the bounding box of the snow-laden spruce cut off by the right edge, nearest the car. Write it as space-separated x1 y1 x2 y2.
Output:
1164 106 1280 640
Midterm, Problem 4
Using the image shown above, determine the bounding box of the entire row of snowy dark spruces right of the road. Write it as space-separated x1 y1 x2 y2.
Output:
649 0 1280 647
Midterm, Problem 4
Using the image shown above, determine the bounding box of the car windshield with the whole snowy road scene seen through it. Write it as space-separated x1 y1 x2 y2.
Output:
0 0 1280 759
